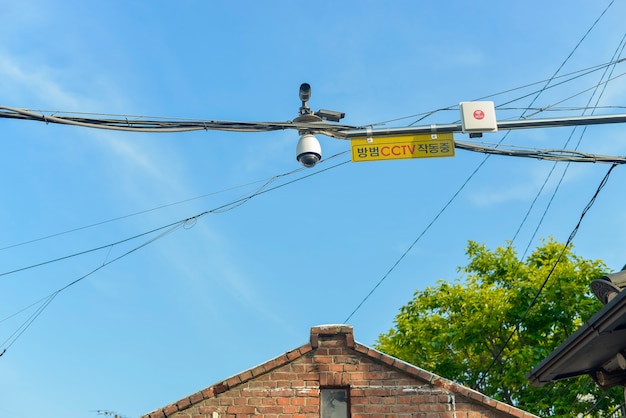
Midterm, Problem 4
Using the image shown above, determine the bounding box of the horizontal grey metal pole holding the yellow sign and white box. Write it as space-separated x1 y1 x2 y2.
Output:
338 114 626 139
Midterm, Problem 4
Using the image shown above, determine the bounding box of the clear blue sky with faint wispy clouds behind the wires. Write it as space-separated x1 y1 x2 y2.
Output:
0 0 626 418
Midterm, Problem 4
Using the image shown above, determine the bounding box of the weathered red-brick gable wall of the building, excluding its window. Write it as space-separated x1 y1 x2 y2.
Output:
144 325 534 418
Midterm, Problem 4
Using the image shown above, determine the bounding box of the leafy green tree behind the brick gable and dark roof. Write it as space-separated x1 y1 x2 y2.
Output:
376 239 622 417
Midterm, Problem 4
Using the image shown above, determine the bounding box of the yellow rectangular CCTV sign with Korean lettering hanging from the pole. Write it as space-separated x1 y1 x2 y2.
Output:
350 133 454 162
